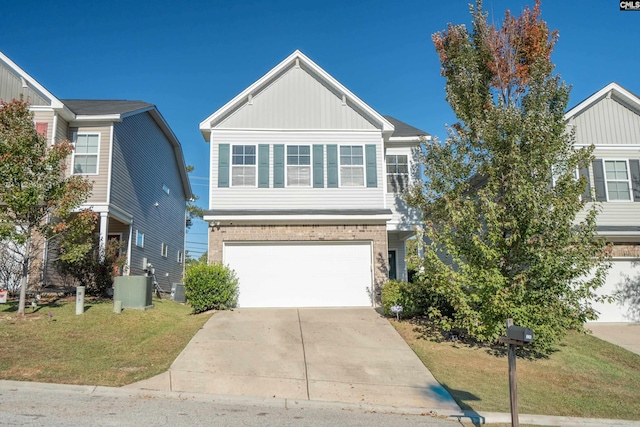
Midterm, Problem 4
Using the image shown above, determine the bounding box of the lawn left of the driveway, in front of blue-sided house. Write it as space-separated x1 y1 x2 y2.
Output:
0 299 211 386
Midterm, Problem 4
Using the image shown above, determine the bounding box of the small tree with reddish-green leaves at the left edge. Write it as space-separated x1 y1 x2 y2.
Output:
0 100 91 315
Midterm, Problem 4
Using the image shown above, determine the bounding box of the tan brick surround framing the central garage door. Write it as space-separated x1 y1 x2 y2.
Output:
209 223 389 304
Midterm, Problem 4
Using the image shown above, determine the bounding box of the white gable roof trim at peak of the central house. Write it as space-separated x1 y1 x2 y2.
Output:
200 50 394 141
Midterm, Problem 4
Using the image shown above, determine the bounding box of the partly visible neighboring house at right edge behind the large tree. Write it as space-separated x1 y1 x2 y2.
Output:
565 83 640 322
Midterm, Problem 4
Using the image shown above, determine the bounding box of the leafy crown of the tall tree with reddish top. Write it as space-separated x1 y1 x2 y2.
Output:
407 1 608 350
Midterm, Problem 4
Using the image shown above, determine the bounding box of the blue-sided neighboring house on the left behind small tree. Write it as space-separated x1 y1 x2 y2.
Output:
0 52 191 289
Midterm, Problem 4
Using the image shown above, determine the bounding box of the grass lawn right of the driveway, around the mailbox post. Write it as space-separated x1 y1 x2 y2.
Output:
390 320 640 420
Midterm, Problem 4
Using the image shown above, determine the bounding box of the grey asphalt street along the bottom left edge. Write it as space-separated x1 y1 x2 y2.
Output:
0 381 460 427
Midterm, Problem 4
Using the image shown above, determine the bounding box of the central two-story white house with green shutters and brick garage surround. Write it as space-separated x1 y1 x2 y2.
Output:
200 51 429 307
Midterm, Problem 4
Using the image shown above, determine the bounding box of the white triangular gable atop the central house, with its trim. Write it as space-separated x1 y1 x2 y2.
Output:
200 50 394 140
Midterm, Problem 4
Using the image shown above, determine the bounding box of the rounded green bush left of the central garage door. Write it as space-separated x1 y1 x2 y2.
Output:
184 263 239 313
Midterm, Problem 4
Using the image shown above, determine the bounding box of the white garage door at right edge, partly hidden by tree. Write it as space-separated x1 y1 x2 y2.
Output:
594 260 640 322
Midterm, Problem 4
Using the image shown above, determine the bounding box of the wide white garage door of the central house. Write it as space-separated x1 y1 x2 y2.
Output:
223 242 373 307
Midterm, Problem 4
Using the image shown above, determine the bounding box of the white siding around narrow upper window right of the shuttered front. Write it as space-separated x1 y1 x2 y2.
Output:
382 144 420 231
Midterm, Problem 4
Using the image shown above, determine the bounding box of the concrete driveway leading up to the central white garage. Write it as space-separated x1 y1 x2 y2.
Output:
127 308 460 412
